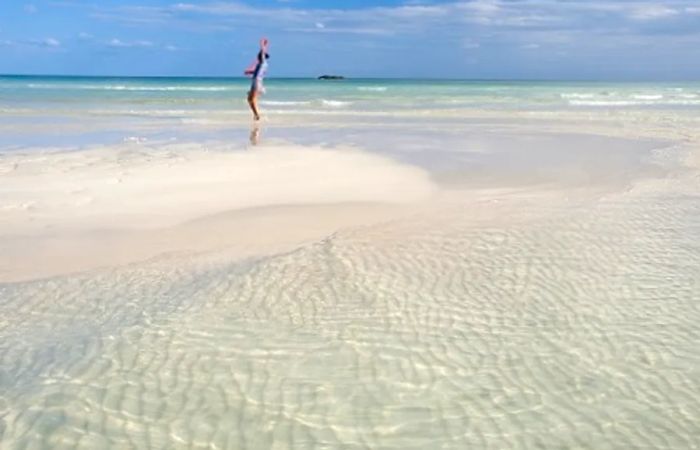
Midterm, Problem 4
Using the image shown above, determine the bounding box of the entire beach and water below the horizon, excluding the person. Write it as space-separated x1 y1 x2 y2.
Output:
0 77 700 449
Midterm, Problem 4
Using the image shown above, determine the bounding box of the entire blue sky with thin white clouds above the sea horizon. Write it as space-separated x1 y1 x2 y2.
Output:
0 0 700 80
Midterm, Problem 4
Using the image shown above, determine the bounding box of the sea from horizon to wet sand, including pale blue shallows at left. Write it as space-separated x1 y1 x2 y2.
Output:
0 75 700 150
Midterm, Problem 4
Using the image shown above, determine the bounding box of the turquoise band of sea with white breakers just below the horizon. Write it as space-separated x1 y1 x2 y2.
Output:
0 76 700 115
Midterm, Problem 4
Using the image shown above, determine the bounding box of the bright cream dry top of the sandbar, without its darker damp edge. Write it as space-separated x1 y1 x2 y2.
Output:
0 144 433 234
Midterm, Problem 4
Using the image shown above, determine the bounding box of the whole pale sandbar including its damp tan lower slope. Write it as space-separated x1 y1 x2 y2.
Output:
0 144 435 281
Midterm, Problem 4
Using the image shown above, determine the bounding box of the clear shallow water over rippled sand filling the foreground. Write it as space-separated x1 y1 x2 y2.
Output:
0 192 700 449
